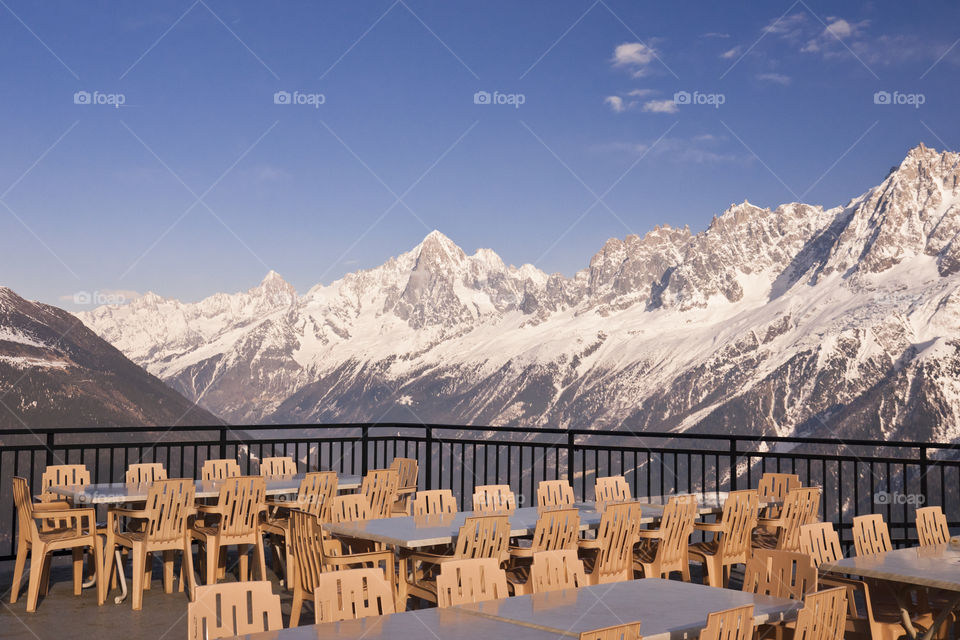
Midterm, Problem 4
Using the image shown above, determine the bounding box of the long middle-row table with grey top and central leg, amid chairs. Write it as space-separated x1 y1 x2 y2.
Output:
323 505 661 603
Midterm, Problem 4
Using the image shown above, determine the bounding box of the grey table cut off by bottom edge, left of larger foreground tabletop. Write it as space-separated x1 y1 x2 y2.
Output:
241 607 557 640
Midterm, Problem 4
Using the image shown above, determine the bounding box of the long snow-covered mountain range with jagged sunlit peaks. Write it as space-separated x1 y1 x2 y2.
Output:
79 145 960 440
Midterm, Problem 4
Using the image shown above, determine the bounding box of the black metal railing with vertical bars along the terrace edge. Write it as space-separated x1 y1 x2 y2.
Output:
0 423 960 560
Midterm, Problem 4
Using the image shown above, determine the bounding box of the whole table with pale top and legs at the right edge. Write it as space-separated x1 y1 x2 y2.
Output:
820 544 960 640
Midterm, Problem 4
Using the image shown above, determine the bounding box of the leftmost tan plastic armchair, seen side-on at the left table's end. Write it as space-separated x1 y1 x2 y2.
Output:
10 477 105 613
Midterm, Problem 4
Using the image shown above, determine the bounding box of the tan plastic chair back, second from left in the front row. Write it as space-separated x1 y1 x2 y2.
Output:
312 569 396 626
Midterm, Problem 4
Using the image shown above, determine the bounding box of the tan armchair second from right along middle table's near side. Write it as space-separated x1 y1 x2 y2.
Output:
689 490 759 587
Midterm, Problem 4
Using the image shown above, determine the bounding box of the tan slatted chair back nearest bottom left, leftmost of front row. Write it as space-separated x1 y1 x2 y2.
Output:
187 580 283 640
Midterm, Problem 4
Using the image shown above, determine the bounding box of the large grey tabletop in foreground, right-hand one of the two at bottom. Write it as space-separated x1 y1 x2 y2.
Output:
461 578 803 640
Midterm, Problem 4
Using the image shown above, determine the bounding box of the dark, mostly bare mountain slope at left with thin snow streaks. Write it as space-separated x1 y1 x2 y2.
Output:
0 287 220 434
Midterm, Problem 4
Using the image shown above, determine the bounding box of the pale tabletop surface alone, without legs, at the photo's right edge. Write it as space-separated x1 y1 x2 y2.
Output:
820 544 960 592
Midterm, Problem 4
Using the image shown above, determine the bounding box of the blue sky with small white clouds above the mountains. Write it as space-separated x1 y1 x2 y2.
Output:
0 0 960 309
